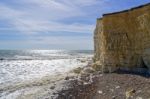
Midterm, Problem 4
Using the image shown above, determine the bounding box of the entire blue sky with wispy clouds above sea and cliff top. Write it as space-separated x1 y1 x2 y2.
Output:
0 0 150 50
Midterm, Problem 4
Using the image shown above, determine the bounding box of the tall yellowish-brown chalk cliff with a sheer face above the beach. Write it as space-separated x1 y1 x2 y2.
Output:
94 4 150 70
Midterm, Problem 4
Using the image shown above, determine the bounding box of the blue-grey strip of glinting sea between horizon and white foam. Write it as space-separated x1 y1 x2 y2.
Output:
0 50 92 61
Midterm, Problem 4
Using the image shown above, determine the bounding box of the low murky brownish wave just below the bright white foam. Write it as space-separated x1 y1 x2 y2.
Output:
0 74 66 99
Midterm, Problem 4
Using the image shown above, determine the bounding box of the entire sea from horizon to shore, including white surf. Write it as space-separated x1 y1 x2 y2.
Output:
0 50 93 99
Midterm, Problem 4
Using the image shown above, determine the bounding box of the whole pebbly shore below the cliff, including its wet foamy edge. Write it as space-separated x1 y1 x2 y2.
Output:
0 60 150 99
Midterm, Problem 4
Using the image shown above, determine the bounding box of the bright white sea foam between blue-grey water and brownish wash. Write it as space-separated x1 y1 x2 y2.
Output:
0 59 86 84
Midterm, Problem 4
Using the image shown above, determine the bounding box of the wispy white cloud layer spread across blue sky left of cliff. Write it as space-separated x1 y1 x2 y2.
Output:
0 0 106 49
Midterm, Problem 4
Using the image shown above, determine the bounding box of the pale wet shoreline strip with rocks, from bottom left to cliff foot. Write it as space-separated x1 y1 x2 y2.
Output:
0 57 91 99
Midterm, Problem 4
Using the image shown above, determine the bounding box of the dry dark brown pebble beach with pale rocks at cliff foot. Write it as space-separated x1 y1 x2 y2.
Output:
49 62 150 99
